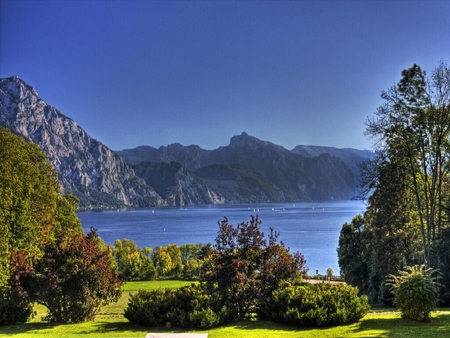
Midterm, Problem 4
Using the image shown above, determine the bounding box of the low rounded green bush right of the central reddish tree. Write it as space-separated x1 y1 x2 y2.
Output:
261 283 370 326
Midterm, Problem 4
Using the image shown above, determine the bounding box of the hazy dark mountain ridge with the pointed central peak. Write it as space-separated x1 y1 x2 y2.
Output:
118 132 356 202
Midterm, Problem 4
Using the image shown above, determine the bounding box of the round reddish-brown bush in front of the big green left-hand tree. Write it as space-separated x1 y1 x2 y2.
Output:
14 229 122 323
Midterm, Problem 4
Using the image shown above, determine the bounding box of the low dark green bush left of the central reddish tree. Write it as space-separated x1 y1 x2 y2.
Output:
124 284 221 329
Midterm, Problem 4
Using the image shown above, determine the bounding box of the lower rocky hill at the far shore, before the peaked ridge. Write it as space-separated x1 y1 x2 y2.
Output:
133 162 283 206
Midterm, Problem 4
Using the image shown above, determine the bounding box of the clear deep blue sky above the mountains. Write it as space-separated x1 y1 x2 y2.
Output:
0 0 450 150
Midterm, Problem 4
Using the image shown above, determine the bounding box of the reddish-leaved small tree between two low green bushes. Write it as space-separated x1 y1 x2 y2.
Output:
200 216 307 321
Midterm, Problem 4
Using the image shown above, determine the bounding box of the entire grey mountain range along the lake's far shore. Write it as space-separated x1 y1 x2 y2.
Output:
0 76 372 208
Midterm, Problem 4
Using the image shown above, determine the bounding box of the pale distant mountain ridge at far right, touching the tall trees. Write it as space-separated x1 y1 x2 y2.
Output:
292 145 375 177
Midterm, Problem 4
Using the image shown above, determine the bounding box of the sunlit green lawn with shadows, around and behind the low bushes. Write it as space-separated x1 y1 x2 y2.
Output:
0 281 450 338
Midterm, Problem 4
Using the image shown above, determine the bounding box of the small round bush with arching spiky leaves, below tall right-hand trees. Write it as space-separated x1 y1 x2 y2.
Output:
388 265 438 321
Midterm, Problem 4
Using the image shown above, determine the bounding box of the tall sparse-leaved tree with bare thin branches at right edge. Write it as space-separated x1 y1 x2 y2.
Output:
366 61 450 267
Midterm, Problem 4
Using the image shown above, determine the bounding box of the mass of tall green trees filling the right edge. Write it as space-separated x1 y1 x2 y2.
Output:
338 61 450 301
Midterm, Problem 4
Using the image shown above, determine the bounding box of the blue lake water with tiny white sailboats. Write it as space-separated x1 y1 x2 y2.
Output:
78 201 365 274
